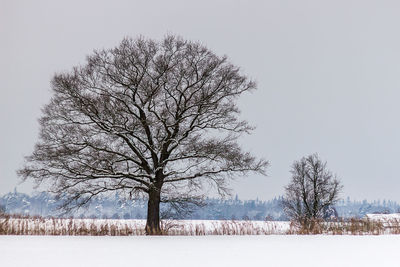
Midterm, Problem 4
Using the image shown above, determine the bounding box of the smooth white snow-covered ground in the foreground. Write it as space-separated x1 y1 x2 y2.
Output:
0 235 400 267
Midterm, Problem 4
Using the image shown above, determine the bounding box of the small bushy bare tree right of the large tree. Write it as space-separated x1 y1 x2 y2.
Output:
283 154 342 226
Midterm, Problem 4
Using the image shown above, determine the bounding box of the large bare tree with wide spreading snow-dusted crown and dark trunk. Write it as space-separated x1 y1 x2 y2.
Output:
18 36 268 234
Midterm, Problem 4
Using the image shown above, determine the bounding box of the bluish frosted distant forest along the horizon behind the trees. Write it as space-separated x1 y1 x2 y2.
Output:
0 191 400 221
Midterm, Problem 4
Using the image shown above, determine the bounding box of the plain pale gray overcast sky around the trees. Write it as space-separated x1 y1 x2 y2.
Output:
0 0 400 202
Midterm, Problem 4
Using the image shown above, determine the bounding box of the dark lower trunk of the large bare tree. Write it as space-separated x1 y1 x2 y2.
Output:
146 189 162 235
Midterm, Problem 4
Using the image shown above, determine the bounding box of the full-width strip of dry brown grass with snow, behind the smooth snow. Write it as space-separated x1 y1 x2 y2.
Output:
0 215 400 236
